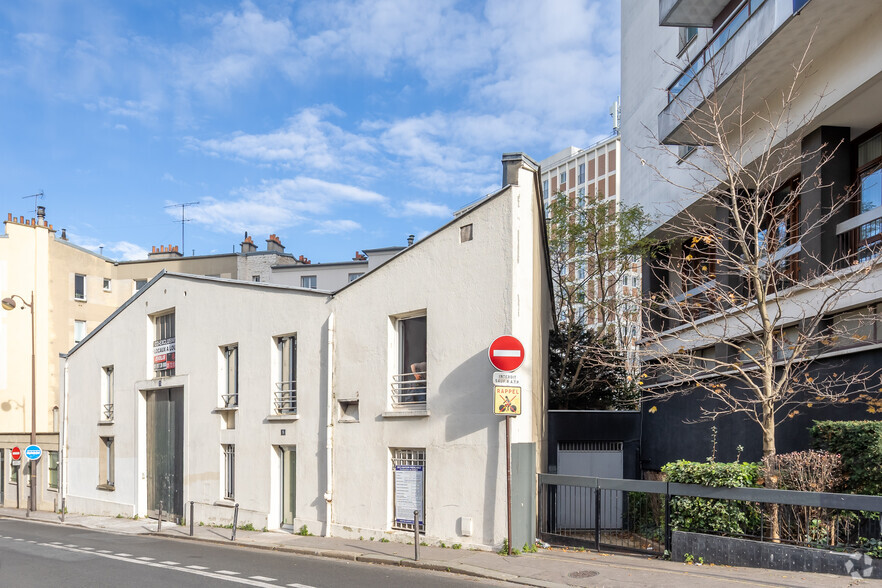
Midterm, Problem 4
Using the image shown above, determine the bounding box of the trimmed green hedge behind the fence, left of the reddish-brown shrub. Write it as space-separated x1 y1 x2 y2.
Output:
662 460 760 535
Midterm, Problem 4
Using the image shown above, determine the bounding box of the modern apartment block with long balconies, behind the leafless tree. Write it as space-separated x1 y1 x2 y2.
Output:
621 0 882 469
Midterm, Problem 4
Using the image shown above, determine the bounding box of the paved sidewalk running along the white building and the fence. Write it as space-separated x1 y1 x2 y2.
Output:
0 508 882 588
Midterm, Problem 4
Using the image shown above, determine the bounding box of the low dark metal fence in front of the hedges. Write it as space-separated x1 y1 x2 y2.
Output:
539 474 882 555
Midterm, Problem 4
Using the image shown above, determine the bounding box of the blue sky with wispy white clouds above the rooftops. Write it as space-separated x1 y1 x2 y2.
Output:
0 0 620 262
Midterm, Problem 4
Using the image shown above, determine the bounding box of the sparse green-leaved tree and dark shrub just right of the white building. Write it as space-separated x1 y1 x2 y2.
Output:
549 188 649 408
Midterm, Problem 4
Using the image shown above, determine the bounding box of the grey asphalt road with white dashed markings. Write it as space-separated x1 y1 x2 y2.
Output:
0 519 502 588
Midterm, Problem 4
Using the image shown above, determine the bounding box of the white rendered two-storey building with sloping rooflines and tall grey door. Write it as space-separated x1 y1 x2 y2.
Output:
63 154 552 547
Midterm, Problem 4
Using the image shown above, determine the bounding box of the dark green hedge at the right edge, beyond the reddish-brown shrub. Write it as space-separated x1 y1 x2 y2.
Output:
811 421 882 495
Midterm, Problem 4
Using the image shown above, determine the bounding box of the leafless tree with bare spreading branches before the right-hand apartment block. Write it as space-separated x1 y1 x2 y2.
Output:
643 38 879 456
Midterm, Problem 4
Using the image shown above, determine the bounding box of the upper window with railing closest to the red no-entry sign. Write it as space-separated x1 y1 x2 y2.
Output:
392 316 428 408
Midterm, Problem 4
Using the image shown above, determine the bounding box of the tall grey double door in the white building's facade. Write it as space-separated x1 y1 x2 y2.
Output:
147 388 184 521
